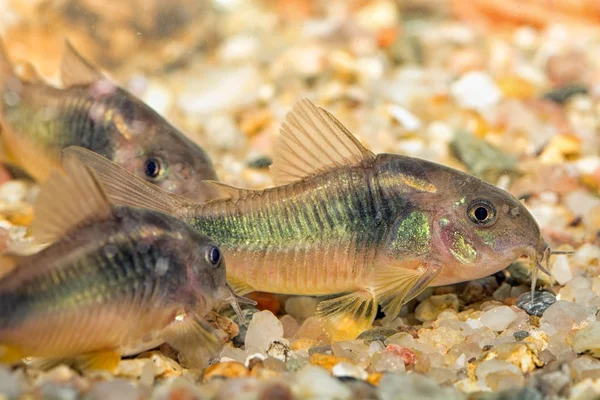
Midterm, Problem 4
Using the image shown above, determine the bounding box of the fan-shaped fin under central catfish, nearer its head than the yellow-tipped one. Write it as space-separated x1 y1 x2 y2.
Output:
375 264 442 317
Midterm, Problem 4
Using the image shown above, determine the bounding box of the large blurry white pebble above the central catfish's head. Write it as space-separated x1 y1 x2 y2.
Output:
450 71 502 111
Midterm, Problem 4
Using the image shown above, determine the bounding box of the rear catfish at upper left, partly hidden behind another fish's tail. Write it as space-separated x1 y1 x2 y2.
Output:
0 36 217 200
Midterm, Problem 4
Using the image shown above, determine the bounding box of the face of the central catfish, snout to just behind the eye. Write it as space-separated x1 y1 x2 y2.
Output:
433 170 550 281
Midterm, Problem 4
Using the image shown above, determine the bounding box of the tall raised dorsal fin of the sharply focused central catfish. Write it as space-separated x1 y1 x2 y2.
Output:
271 99 375 185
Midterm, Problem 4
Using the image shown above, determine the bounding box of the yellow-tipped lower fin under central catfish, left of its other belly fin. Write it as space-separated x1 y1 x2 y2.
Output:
317 290 377 341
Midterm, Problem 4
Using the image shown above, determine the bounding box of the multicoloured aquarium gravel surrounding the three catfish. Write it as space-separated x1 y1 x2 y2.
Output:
0 0 600 400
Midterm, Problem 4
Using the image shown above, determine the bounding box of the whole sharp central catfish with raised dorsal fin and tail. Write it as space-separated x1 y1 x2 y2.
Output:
65 100 550 339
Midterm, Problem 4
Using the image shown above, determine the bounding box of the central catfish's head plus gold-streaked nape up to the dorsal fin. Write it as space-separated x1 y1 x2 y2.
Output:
376 155 550 284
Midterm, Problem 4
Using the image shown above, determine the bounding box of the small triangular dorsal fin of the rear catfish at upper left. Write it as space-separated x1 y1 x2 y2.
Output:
60 40 106 88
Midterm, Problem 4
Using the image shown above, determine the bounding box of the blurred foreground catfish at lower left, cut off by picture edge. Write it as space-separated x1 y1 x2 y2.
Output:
0 156 244 370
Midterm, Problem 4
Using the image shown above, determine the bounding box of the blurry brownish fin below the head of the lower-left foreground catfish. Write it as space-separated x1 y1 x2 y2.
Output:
162 315 223 367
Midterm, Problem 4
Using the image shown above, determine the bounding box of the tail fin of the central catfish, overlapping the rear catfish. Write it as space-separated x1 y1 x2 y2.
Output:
63 146 191 216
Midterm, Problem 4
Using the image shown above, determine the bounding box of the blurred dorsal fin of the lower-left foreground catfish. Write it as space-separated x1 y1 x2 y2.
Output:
31 155 112 243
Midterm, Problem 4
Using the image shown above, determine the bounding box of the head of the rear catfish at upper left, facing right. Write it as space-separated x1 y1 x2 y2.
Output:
111 91 217 201
